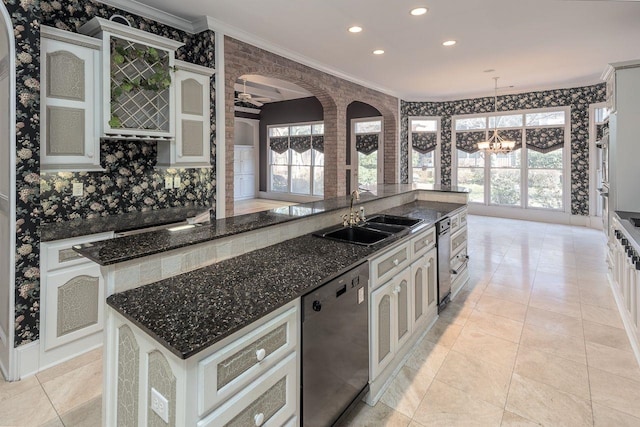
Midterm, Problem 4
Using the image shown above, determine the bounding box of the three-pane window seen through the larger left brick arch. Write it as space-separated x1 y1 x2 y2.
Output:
268 123 324 196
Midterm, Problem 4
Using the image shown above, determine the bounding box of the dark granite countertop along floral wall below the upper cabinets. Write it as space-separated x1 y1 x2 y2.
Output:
40 206 208 242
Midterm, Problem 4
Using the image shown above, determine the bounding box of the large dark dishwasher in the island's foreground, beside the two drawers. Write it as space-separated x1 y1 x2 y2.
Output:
301 262 369 427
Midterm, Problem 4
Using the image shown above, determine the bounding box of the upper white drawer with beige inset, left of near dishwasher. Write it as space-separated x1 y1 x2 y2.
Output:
198 307 298 414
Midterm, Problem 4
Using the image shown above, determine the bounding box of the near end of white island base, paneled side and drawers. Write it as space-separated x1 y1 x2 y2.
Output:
102 300 300 427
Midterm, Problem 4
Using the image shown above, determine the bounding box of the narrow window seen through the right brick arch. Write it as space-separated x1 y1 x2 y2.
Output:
352 118 382 186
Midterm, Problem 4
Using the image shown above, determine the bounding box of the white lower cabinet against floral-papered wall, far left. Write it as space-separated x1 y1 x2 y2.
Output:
40 232 113 369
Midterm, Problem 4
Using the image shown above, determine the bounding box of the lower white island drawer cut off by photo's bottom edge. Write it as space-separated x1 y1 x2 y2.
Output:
197 353 298 427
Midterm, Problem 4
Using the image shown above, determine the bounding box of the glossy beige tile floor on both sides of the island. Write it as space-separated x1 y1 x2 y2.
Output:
5 216 640 427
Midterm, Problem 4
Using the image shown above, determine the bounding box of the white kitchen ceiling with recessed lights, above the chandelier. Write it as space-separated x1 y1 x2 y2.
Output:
120 0 640 101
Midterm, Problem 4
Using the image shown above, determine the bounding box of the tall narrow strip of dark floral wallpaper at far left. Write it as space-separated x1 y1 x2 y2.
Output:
3 0 41 346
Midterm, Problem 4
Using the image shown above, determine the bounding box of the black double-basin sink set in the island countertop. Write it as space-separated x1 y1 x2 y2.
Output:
314 215 423 246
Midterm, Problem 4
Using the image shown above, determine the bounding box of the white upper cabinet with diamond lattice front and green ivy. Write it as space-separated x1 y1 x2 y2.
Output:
79 18 184 139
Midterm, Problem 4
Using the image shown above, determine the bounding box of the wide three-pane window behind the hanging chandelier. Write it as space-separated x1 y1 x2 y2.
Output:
453 108 570 210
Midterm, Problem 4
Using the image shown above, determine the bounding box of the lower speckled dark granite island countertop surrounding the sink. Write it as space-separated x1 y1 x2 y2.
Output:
107 201 464 359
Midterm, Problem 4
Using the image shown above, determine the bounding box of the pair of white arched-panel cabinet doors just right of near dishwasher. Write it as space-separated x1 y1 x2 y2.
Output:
370 268 412 379
